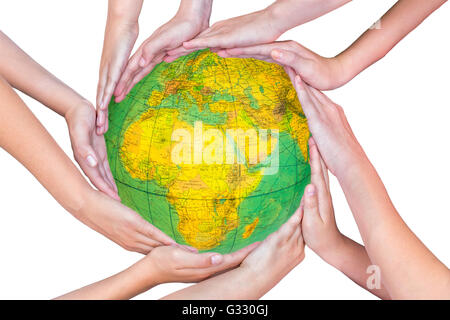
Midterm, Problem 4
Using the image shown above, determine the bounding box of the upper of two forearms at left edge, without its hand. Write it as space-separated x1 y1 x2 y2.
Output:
0 32 83 116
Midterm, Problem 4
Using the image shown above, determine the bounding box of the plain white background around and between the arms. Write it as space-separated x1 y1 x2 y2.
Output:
0 0 450 299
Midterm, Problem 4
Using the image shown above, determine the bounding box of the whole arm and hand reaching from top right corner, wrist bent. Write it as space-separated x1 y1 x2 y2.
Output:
223 0 446 90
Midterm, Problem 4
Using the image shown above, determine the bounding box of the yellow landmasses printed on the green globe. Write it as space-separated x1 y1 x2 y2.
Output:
120 51 308 250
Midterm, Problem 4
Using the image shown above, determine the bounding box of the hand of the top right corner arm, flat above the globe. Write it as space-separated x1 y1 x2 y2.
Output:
218 41 351 90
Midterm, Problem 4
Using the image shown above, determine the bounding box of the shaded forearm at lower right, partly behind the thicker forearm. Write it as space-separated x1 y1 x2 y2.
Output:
320 235 390 299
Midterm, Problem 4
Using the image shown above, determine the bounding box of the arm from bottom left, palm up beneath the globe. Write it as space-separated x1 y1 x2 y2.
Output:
57 245 255 300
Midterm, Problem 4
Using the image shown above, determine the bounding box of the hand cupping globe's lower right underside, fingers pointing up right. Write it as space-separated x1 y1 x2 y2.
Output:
240 209 305 284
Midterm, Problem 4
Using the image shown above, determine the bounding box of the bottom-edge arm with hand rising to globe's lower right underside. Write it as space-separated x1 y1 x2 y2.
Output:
163 210 305 300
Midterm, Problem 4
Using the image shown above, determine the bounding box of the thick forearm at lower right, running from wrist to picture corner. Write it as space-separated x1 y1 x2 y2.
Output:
338 160 450 299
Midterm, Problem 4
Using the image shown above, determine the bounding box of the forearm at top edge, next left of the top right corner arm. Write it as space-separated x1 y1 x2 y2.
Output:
266 0 351 34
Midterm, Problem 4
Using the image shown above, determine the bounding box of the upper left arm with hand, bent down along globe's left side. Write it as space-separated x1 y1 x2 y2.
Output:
0 32 118 199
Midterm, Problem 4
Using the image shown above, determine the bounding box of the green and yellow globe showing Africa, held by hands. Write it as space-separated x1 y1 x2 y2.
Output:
105 49 310 253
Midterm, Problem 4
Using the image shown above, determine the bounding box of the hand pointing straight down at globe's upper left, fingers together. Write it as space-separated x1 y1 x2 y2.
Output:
97 19 139 135
